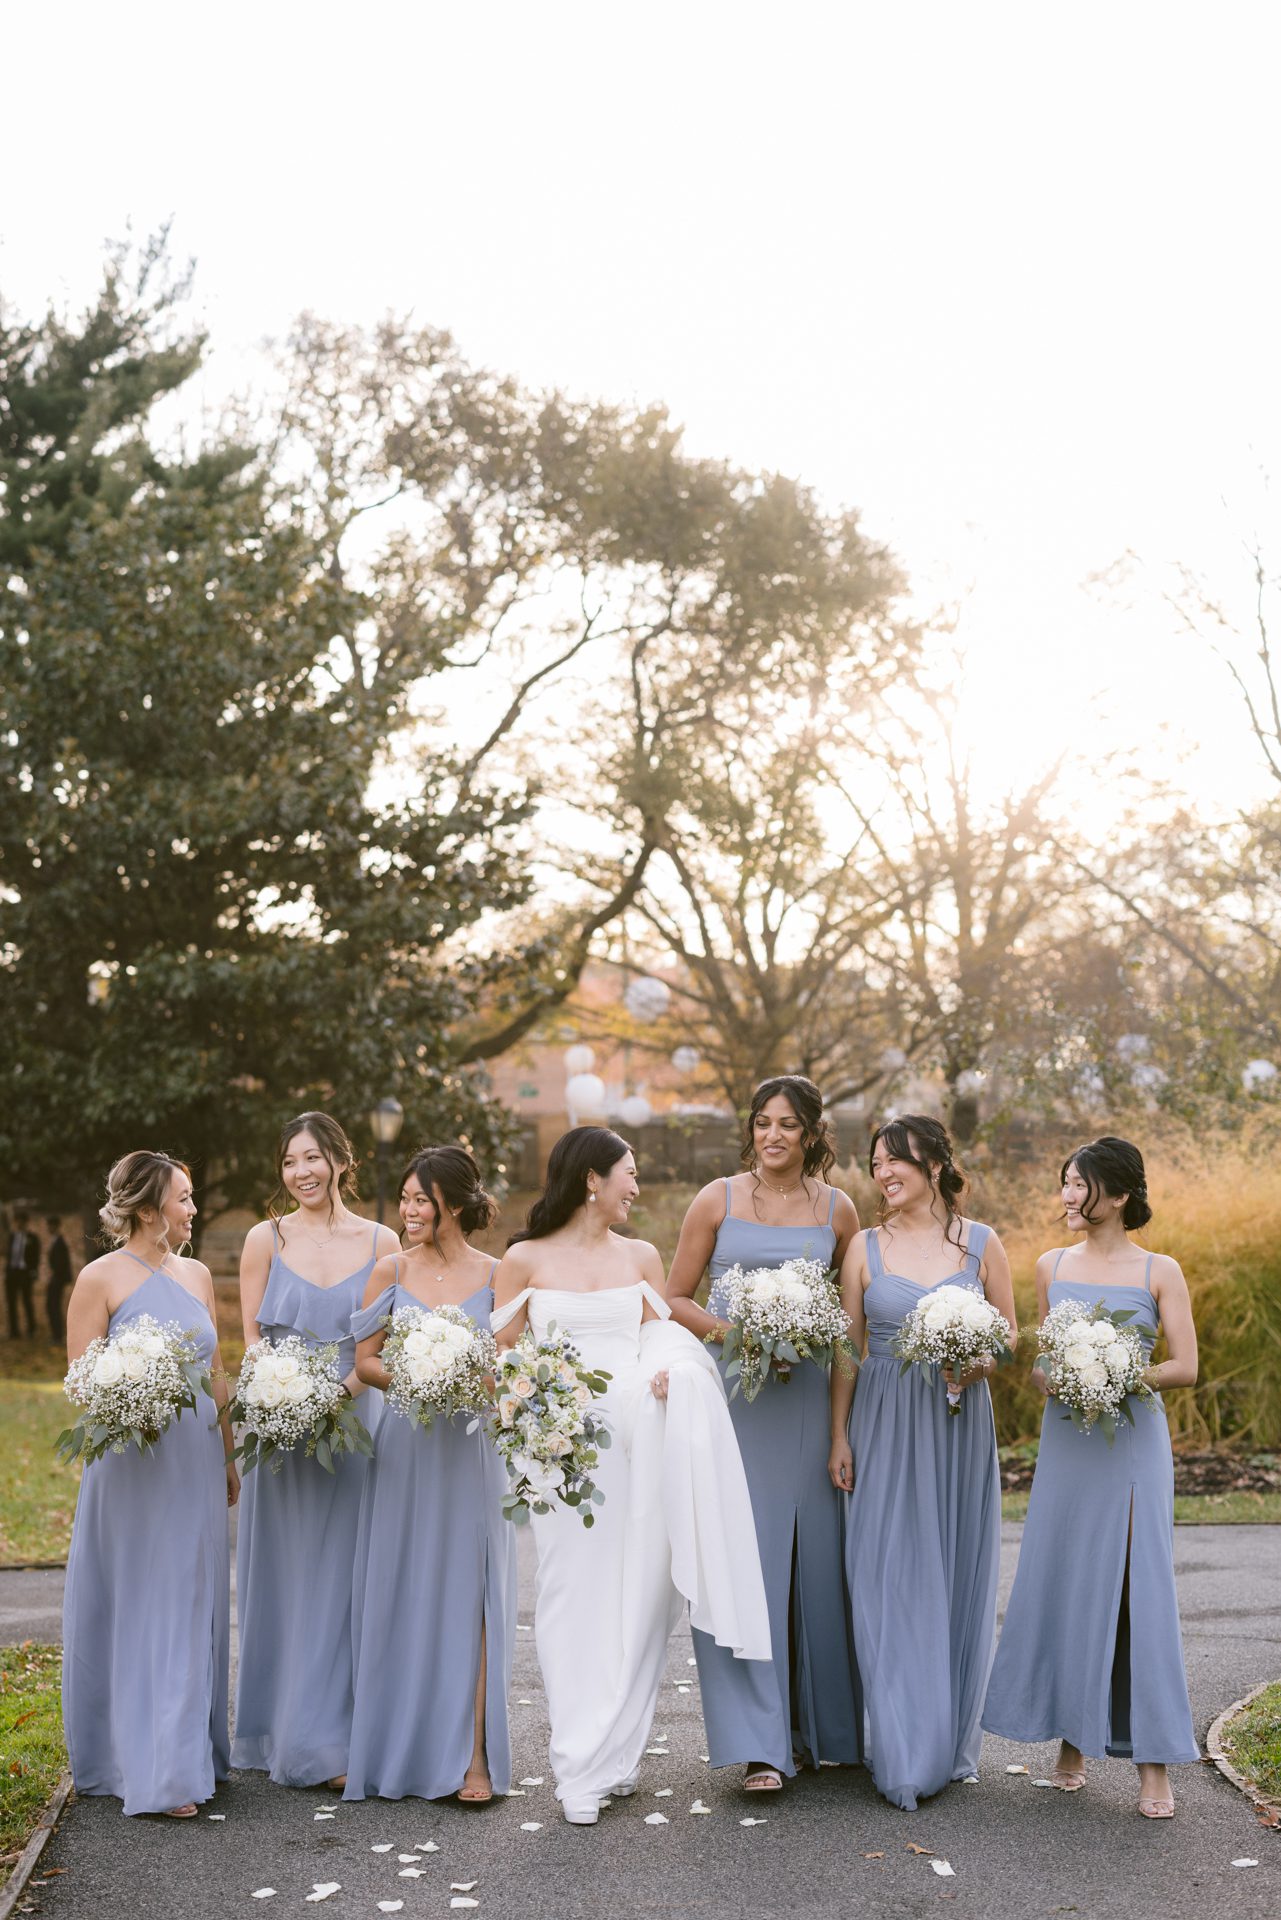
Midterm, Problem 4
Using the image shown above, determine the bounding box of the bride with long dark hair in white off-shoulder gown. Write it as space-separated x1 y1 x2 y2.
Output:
492 1127 770 1826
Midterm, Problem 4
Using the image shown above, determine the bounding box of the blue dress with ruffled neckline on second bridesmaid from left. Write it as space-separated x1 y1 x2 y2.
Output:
230 1223 382 1788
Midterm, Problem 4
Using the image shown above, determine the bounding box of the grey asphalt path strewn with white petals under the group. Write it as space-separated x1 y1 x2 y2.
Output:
0 1526 1281 1920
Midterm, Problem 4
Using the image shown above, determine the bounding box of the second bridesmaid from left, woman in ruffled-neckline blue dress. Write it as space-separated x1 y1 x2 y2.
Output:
230 1114 398 1791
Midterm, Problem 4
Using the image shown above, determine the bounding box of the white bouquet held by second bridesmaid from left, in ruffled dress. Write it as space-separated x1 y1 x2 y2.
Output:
227 1332 375 1473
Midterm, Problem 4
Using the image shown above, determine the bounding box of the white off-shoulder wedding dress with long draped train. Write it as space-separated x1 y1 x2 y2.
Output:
492 1281 770 1820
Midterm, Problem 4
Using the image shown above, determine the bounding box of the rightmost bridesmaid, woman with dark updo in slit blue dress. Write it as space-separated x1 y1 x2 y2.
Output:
983 1135 1200 1820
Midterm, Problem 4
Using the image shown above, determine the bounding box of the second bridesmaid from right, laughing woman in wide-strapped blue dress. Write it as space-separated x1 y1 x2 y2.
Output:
830 1114 1014 1809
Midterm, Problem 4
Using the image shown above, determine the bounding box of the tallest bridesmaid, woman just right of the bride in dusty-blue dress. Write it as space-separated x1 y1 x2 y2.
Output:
668 1073 860 1793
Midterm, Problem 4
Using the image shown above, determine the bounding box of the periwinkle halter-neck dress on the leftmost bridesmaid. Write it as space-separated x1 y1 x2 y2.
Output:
61 1254 230 1812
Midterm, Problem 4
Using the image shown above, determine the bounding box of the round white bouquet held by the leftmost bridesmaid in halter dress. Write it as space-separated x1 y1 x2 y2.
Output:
54 1313 204 1461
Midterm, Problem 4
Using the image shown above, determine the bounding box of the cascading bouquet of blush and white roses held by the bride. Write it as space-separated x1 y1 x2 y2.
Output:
490 1325 611 1526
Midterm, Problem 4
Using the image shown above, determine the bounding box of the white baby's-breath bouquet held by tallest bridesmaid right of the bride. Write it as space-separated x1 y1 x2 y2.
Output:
718 1260 853 1400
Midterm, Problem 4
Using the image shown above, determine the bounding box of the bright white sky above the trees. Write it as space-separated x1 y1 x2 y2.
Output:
0 0 1281 806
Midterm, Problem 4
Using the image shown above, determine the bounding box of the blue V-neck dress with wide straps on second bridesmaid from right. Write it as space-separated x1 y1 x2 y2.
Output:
845 1221 1001 1809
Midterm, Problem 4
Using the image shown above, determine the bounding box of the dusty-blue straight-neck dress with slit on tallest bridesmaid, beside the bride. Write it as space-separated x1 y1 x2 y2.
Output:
693 1181 860 1774
